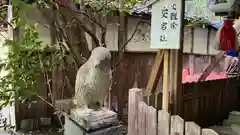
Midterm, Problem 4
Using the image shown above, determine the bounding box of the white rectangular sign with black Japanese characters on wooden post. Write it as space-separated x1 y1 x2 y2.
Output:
151 0 182 49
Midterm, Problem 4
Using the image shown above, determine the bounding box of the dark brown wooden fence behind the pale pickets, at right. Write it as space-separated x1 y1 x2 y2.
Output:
181 77 240 127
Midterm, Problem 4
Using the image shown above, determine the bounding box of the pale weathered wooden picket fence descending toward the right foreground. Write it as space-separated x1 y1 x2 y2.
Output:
128 88 218 135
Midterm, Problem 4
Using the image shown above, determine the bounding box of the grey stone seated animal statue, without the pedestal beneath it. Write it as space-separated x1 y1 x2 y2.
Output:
73 47 112 110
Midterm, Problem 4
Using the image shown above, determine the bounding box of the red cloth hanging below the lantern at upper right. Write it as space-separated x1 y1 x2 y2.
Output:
220 20 237 51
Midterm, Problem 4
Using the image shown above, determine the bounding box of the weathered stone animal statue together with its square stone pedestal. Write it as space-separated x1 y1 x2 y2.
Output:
64 47 122 135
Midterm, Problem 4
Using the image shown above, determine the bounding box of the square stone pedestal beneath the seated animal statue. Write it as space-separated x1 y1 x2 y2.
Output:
64 108 122 135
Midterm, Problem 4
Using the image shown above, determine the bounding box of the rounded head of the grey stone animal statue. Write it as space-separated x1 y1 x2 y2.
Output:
90 47 111 67
